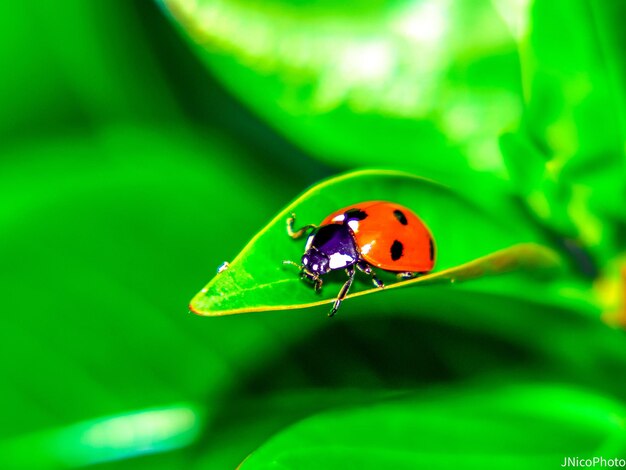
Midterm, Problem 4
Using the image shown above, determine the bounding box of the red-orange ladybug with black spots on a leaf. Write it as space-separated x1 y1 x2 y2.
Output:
284 201 435 317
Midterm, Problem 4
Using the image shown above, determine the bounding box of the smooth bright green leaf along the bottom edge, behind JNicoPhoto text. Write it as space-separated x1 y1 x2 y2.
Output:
241 384 626 470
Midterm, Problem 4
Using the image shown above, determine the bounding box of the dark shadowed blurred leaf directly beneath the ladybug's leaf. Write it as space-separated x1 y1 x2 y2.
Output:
195 276 626 469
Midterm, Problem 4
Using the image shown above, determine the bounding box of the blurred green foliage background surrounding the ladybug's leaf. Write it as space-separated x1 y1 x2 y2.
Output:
0 0 626 469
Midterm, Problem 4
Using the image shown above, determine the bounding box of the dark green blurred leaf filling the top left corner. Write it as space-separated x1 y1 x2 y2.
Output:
0 0 182 145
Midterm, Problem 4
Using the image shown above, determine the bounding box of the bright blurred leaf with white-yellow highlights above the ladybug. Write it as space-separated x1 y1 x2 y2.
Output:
162 0 526 176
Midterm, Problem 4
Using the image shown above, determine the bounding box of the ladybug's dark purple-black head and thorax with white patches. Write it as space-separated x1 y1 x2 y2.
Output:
302 224 359 275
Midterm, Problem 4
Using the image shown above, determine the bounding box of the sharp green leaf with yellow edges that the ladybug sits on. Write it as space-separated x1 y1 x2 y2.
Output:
190 170 558 315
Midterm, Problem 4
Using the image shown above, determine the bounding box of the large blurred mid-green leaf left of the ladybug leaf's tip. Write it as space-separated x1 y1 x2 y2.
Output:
0 123 322 468
